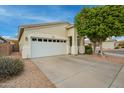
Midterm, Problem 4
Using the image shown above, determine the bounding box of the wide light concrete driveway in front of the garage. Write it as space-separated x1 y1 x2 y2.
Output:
31 55 124 88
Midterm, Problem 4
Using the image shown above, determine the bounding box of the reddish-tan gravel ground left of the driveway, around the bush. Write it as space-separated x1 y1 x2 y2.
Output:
0 54 55 88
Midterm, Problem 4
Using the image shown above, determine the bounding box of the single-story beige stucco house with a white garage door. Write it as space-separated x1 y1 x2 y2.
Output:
18 22 84 58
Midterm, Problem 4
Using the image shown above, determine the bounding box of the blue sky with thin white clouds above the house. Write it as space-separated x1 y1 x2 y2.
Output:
0 5 123 39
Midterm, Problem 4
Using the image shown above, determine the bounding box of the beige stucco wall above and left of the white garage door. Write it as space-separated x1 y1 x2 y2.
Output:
19 24 70 58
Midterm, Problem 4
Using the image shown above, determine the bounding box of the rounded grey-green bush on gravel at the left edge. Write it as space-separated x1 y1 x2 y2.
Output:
0 57 24 78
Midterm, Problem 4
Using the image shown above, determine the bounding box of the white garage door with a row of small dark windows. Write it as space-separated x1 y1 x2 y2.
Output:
31 37 67 58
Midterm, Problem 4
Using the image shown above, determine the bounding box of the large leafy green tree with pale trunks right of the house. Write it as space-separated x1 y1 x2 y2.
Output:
74 5 124 55
